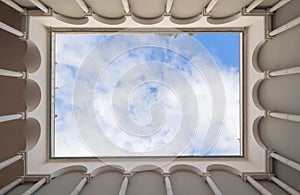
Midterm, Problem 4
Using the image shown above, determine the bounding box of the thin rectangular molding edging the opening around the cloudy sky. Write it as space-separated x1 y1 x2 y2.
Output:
47 27 248 161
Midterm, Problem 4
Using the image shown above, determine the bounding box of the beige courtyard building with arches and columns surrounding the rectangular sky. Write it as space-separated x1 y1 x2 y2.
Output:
0 0 300 195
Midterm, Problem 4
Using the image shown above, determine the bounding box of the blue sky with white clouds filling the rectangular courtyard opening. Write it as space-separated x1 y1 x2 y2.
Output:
54 32 241 157
